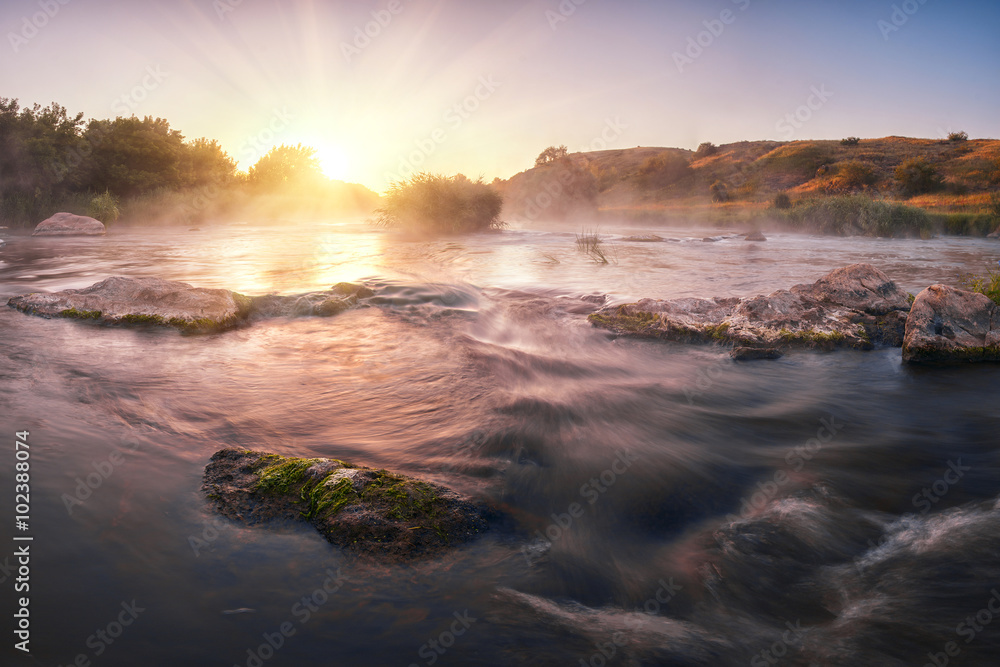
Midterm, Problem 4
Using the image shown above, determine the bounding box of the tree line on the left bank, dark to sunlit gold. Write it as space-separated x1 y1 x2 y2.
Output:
0 98 377 225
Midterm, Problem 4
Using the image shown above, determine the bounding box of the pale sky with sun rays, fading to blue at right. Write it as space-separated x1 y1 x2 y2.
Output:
0 0 1000 192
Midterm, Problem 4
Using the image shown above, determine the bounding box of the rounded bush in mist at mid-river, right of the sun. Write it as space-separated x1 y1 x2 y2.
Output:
373 173 505 232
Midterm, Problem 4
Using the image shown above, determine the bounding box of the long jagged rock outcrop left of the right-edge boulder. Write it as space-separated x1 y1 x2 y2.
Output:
590 264 910 350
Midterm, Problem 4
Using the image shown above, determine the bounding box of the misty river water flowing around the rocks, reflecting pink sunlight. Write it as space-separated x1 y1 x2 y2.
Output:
0 222 1000 667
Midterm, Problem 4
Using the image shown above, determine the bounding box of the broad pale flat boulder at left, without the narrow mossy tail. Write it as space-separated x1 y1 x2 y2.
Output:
7 276 252 331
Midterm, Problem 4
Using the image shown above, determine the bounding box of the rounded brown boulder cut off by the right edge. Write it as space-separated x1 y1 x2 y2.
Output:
903 285 1000 363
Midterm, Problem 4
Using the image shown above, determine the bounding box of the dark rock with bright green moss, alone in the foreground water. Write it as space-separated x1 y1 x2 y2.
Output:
203 449 489 562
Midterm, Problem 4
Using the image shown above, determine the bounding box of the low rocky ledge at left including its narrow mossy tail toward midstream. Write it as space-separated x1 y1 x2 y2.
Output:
7 276 374 333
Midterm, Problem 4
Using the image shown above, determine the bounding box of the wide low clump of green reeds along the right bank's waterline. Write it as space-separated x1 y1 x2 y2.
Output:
784 195 934 238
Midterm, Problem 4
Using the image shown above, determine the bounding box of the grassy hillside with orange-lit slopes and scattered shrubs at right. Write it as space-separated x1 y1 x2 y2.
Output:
498 137 1000 233
